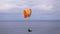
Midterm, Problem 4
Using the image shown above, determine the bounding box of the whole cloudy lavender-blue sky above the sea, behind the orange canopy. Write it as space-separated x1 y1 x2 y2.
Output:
0 0 60 20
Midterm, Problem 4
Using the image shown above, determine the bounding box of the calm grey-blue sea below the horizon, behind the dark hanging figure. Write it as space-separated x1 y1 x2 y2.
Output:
0 21 60 34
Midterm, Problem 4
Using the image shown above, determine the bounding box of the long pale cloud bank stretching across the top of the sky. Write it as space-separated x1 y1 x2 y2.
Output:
0 0 53 10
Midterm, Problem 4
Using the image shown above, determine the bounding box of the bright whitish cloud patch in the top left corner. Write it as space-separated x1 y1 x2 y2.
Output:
0 0 16 10
